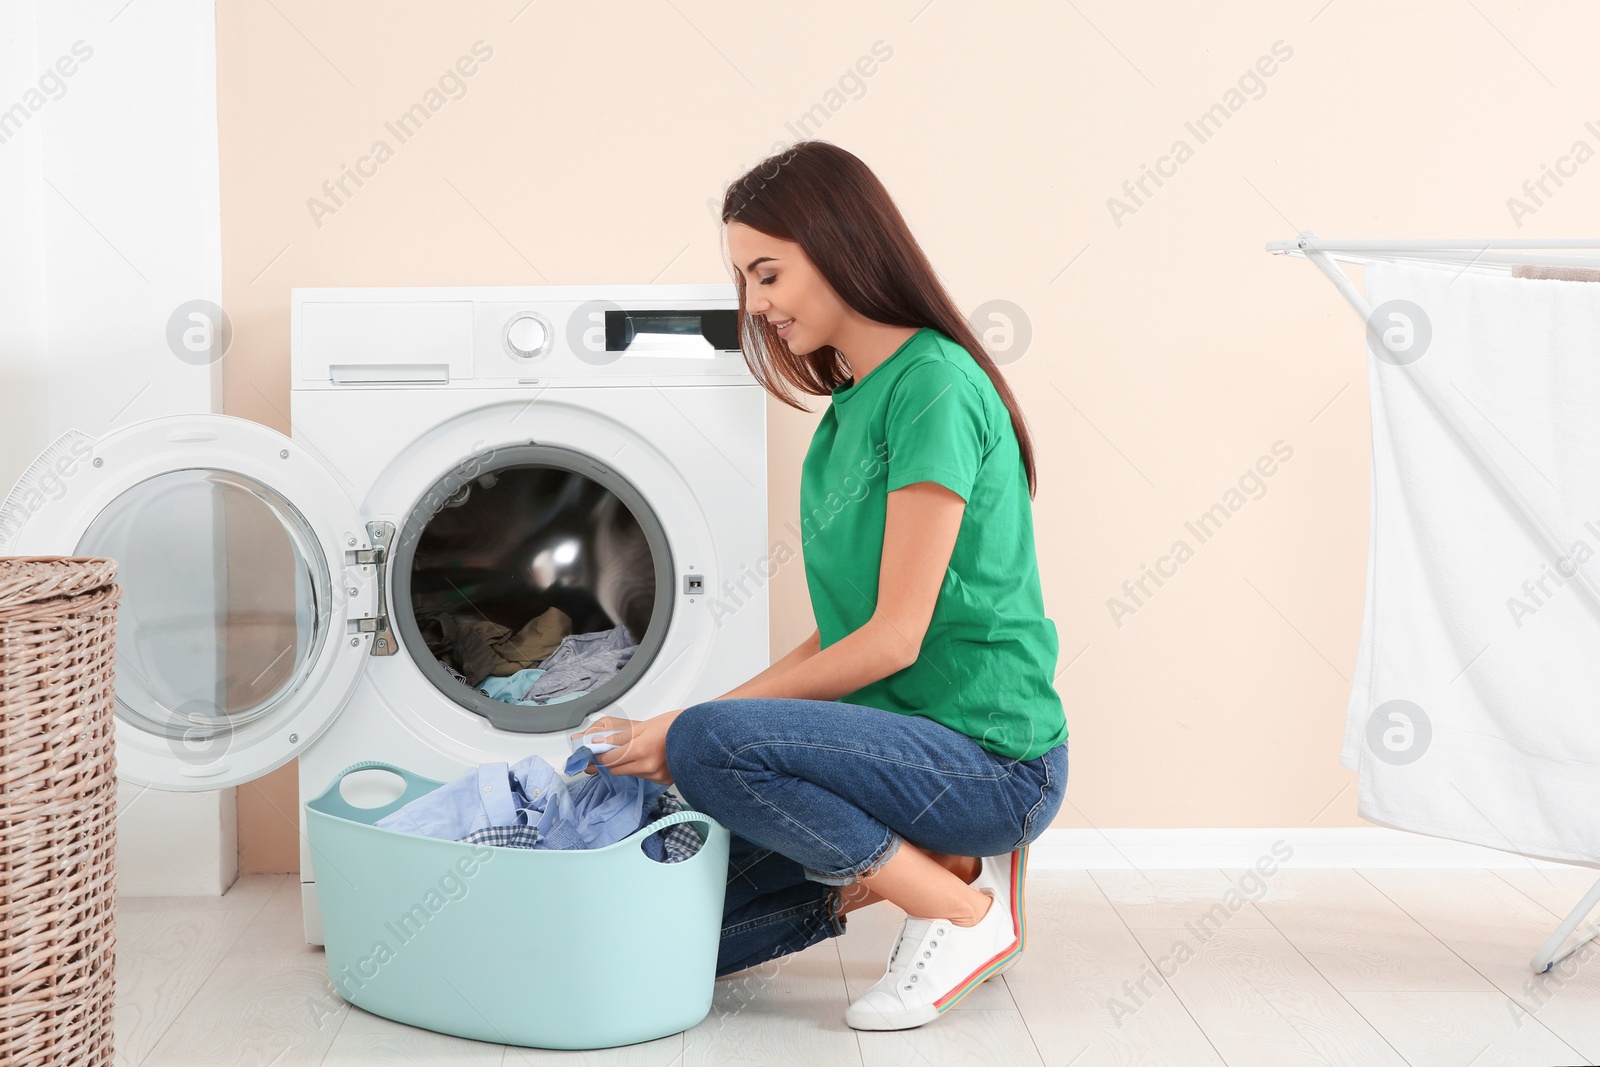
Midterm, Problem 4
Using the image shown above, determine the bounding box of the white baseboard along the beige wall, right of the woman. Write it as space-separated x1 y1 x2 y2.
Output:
1027 825 1600 877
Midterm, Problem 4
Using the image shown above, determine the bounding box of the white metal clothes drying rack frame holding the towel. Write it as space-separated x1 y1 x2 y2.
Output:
1267 230 1600 974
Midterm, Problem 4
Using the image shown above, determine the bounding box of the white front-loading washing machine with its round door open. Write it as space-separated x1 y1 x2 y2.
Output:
5 285 770 944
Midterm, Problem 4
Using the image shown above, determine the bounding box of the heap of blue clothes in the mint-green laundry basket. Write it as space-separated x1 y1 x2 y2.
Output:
373 745 667 849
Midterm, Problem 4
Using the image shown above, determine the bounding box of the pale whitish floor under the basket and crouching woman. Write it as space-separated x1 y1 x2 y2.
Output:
117 869 1600 1067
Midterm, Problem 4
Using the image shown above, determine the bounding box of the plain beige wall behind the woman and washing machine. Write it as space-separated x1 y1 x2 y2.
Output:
218 0 1600 870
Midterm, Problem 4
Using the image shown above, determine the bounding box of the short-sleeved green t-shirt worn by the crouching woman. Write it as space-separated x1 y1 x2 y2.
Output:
800 328 1067 760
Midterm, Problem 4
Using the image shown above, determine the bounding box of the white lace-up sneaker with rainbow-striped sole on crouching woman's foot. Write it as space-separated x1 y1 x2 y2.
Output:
845 872 1021 1030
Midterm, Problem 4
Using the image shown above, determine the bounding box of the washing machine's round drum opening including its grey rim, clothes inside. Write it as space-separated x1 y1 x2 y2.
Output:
400 445 674 733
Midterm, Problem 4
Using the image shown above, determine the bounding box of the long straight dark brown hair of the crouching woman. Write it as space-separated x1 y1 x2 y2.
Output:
722 141 1035 498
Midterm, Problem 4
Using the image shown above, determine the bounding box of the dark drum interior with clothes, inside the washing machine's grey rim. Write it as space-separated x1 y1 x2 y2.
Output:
410 466 656 705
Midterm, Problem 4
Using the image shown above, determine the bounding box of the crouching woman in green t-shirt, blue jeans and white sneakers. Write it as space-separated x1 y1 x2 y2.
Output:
569 141 1067 1030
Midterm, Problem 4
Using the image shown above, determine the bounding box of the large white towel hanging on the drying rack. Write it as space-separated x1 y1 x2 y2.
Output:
1341 255 1600 865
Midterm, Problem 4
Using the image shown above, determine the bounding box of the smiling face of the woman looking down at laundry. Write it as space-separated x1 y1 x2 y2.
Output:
728 222 850 355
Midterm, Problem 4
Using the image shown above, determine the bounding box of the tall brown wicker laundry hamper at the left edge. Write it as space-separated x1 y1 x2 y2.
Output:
0 557 122 1067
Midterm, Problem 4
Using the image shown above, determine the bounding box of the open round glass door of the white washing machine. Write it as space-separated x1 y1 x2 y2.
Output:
0 414 374 790
